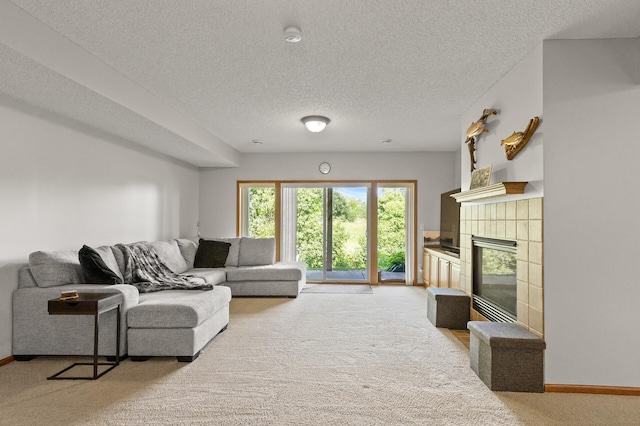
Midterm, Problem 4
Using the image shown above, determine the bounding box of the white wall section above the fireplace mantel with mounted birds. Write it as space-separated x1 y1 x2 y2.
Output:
460 45 545 201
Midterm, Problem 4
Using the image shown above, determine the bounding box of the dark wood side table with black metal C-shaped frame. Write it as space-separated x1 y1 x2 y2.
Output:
47 292 124 380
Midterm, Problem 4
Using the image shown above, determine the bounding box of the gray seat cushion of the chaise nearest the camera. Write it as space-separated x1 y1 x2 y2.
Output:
127 286 231 328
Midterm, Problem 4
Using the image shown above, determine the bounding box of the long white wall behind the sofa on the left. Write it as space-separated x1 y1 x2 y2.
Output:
0 97 199 359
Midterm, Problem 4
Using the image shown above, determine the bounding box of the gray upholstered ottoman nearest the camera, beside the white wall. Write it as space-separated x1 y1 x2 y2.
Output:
469 321 546 392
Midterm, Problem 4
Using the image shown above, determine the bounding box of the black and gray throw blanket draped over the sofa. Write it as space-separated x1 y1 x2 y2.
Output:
116 242 213 293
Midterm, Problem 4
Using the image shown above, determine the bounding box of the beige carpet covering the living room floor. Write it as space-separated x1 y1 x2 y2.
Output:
0 286 640 426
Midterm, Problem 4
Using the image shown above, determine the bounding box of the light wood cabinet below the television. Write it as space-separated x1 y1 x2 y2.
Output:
422 248 460 288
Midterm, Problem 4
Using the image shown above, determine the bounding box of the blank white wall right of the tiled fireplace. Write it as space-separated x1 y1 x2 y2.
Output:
544 39 640 387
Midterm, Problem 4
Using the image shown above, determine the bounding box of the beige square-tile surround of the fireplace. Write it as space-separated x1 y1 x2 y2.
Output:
460 198 544 337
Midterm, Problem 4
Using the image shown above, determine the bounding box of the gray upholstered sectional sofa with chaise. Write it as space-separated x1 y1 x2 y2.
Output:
13 237 306 362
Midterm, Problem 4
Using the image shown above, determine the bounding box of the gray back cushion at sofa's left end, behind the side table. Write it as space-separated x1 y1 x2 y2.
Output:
29 251 84 287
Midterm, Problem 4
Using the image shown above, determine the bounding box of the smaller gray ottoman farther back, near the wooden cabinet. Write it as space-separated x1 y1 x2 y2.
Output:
427 287 471 330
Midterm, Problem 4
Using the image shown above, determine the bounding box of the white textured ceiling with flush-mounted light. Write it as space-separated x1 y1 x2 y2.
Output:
0 0 640 166
